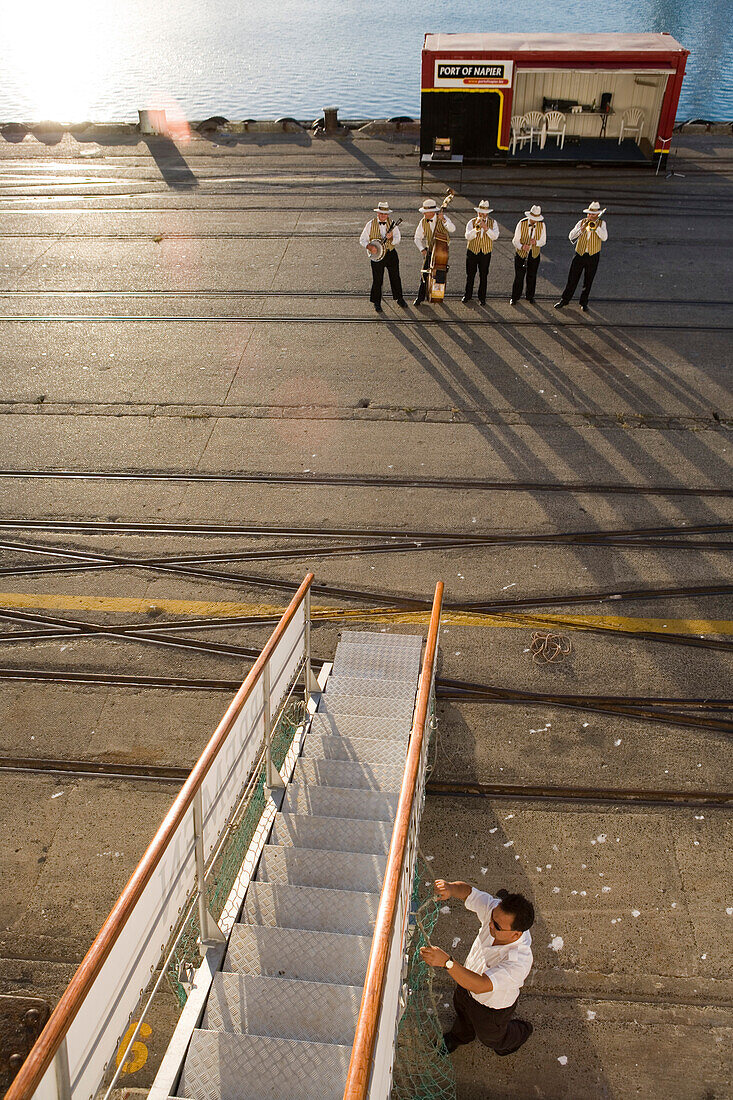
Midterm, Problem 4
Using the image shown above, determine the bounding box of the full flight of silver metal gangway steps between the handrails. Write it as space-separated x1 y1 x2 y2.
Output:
177 631 422 1100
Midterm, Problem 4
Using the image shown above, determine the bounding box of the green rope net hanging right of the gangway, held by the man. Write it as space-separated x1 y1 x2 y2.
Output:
392 856 457 1100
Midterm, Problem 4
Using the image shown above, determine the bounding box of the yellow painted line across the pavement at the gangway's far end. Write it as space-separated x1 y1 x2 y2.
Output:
0 592 733 635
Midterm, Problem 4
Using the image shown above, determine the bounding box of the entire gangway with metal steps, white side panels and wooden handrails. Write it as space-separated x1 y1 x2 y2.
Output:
7 574 442 1100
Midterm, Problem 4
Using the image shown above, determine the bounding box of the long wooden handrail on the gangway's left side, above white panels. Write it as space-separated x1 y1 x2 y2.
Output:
4 573 314 1100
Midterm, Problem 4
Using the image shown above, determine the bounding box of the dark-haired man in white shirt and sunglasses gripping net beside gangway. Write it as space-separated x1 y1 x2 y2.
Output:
420 879 535 1056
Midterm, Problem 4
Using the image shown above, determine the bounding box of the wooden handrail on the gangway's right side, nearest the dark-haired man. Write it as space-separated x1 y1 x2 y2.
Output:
341 581 442 1100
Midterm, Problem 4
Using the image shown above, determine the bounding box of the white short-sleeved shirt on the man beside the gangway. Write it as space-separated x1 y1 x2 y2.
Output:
463 887 533 1009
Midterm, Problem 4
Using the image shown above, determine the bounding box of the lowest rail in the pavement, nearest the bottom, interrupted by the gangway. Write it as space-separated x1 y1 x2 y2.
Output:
0 756 733 810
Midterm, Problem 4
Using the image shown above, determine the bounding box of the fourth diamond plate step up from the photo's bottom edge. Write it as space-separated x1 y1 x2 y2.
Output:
242 881 380 936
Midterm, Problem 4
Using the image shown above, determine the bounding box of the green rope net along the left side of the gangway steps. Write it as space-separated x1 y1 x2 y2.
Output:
167 700 306 1008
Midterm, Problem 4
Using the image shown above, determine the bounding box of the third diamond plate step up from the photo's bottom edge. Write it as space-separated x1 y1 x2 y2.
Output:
223 924 372 987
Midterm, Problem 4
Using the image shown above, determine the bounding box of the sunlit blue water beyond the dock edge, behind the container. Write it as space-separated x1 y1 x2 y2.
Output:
0 0 733 122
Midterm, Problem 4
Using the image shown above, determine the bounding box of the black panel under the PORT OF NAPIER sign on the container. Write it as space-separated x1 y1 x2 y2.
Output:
420 91 501 161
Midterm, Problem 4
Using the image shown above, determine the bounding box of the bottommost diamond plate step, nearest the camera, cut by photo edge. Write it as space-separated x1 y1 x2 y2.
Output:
178 1031 351 1100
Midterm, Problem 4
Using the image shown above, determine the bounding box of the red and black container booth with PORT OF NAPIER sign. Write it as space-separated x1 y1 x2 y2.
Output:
420 34 689 166
